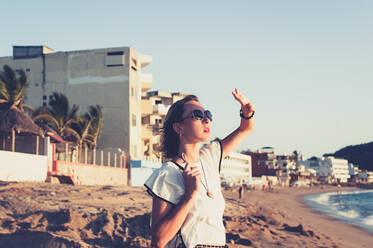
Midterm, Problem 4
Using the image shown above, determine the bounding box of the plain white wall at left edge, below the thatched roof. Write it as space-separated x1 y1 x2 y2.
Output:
0 150 48 182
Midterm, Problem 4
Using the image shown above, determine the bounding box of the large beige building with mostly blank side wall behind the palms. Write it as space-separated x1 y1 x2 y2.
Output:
0 46 152 162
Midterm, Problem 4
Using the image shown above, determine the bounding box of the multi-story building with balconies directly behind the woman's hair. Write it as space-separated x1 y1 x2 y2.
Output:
141 91 187 159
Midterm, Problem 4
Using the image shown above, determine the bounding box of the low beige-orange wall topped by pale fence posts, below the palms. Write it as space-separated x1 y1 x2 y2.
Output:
53 161 128 185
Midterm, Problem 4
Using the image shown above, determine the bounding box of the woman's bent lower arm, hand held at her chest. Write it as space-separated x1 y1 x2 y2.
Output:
150 164 200 248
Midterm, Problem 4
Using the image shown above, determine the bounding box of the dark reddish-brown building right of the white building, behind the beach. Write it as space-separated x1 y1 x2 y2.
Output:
243 147 277 177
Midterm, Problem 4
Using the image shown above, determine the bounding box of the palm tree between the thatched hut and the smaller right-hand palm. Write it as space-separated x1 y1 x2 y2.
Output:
32 92 79 139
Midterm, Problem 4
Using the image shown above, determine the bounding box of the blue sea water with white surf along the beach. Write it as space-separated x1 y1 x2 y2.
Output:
304 190 373 232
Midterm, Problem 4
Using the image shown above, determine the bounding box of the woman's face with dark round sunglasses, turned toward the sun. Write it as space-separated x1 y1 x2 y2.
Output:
179 101 211 143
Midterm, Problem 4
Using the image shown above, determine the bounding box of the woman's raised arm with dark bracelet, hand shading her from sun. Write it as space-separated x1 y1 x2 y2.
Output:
221 89 255 158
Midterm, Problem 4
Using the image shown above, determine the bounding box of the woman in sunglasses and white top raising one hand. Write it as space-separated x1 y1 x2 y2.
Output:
145 89 255 248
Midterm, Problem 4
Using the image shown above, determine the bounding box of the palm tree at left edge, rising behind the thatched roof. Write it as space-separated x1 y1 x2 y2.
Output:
0 65 28 110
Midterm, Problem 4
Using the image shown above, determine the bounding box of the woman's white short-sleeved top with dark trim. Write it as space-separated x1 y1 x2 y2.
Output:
144 141 225 248
